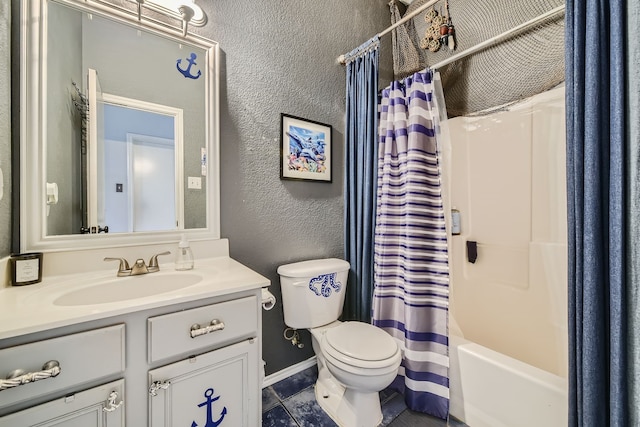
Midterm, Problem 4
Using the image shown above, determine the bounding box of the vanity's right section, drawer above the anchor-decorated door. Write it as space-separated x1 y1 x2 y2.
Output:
148 296 260 427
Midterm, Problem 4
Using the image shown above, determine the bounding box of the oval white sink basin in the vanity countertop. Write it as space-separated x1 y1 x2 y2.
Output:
53 273 202 306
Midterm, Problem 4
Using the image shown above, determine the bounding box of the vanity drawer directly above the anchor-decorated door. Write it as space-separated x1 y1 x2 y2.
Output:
147 296 259 363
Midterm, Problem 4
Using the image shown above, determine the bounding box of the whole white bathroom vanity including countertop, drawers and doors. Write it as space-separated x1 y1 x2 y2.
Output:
0 252 269 427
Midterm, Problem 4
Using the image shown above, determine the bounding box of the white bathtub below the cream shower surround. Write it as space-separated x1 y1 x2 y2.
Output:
449 335 567 427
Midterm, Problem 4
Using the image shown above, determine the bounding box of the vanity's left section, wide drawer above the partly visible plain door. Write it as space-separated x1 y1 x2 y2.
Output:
0 324 125 427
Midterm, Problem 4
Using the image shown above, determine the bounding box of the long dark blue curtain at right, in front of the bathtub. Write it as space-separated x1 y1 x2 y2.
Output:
565 0 637 427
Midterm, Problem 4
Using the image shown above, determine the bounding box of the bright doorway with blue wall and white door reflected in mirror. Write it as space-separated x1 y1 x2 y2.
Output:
98 94 184 233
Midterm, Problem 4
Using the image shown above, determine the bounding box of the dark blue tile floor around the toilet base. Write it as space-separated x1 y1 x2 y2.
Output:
262 366 466 427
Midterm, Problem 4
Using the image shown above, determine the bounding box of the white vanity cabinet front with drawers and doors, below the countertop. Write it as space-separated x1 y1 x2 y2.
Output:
0 287 262 427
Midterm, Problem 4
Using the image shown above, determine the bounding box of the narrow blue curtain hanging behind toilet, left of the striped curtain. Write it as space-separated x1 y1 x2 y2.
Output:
342 37 380 322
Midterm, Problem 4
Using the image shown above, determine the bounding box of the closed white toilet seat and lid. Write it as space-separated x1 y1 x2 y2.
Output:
321 322 400 369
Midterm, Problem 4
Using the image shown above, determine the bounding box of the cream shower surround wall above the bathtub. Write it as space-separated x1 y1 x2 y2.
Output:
449 88 567 376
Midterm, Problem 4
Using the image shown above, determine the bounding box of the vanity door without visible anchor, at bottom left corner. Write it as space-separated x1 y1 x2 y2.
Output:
0 380 124 427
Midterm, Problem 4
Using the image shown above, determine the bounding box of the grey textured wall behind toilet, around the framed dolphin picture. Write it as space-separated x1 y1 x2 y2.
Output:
189 0 391 374
